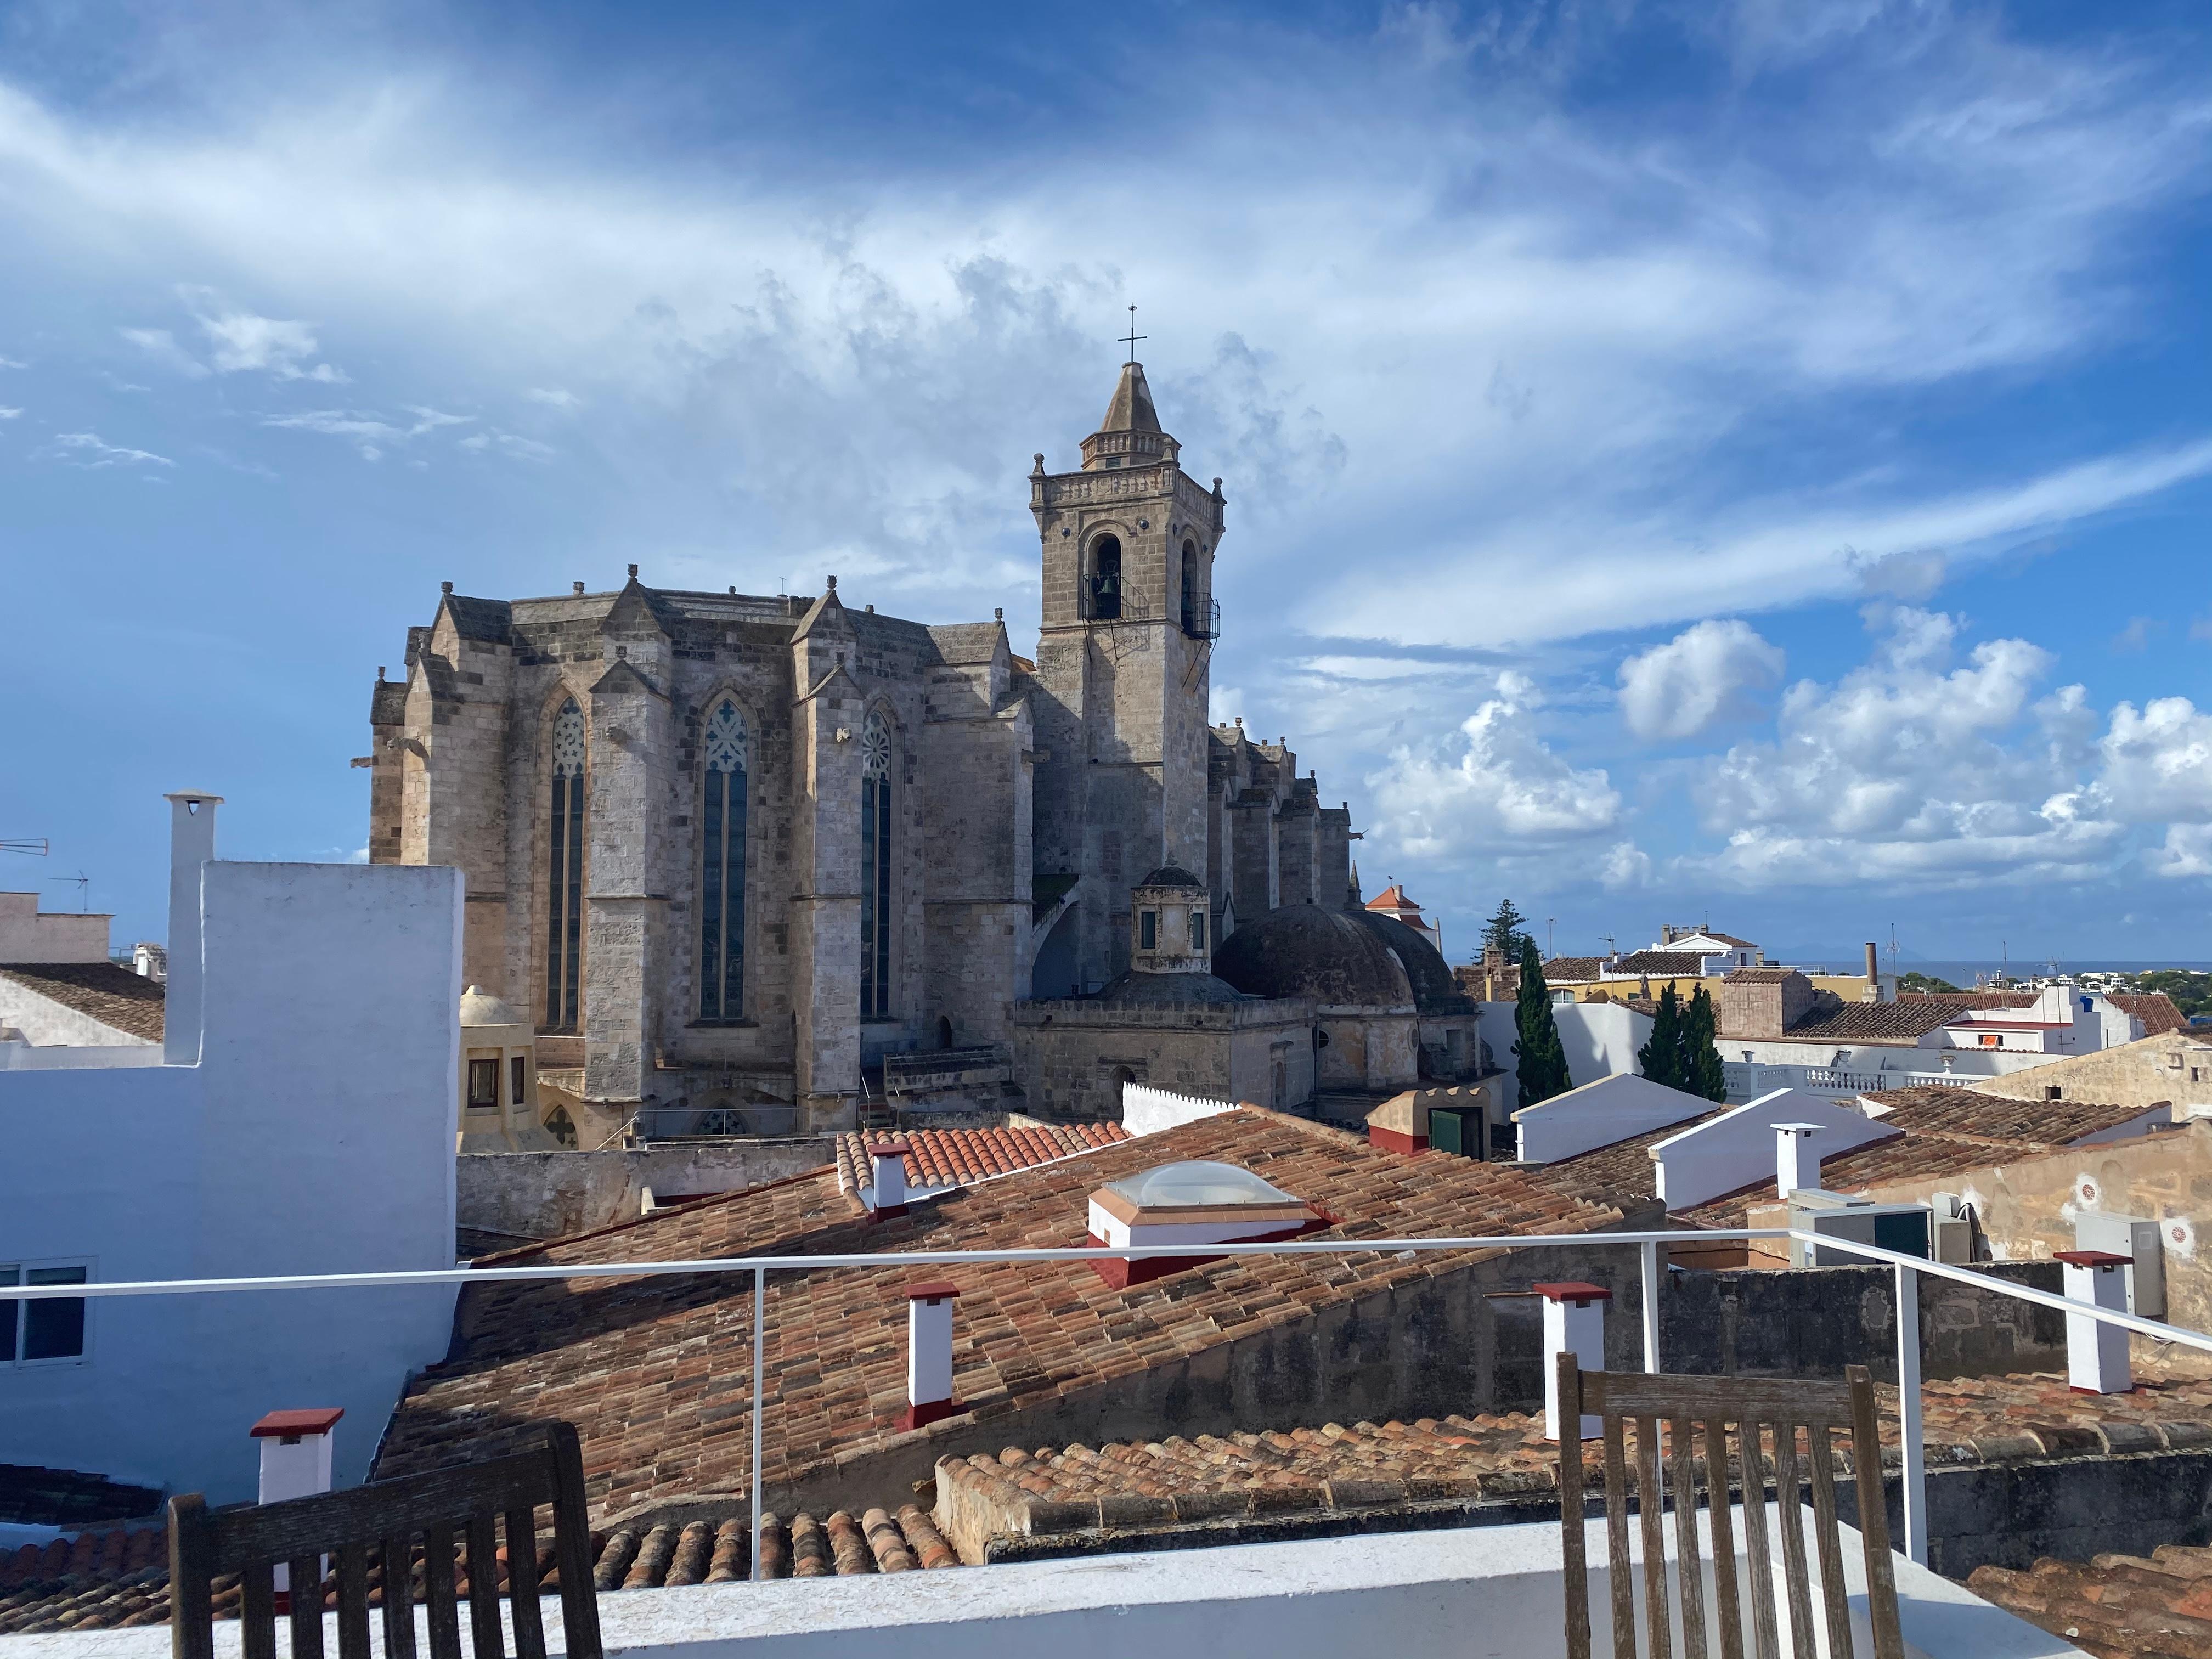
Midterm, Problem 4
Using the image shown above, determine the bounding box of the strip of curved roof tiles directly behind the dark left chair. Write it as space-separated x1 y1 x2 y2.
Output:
0 1504 960 1637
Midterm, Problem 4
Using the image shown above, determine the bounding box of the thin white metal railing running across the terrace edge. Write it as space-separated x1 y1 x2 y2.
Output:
0 1228 2212 1584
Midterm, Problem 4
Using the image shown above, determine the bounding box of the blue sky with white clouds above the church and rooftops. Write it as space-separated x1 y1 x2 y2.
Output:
0 0 2212 958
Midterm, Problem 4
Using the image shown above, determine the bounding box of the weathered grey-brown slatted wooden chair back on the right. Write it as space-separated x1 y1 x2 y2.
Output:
1560 1354 1905 1659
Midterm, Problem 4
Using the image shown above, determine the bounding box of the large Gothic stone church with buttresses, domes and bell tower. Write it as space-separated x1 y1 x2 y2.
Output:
367 360 1475 1130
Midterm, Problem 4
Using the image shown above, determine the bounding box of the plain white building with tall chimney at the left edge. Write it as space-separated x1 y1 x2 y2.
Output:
0 794 462 1502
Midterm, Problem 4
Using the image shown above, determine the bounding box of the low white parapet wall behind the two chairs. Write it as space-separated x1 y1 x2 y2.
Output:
7 1506 2084 1659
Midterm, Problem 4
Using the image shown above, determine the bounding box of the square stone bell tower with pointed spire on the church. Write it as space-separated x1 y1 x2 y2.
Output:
1029 358 1226 989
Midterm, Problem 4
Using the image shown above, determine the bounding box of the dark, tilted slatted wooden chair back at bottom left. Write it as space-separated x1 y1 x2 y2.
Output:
168 1423 602 1659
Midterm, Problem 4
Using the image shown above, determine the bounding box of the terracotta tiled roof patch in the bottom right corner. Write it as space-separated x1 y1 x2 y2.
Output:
1966 1544 2212 1659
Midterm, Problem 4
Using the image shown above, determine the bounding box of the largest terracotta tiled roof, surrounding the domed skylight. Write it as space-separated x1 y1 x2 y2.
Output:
378 1108 1619 1513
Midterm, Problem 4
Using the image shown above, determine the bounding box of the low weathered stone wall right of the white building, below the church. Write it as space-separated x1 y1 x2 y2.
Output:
454 1135 836 1239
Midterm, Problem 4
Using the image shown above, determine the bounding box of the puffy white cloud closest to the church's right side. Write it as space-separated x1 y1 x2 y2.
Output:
1367 670 1621 858
